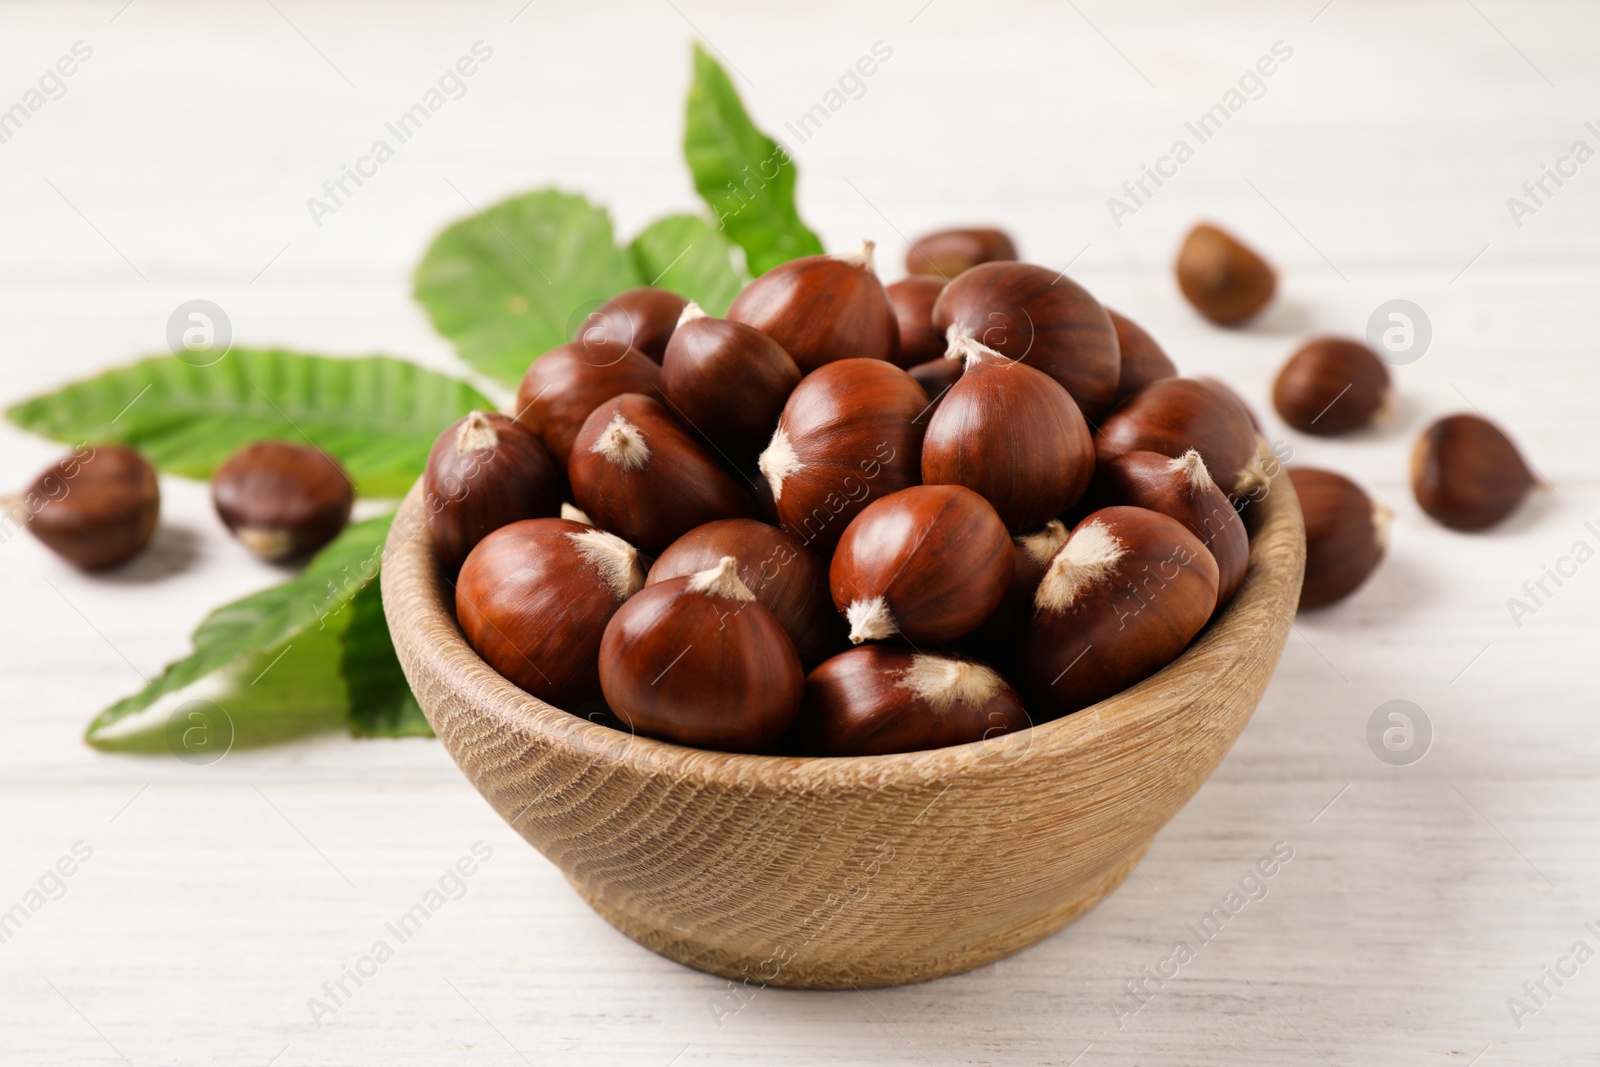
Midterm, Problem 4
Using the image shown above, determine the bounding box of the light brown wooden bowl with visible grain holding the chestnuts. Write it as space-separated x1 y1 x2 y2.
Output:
382 472 1306 989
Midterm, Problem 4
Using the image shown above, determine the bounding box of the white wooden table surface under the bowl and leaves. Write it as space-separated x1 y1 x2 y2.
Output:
0 0 1600 1067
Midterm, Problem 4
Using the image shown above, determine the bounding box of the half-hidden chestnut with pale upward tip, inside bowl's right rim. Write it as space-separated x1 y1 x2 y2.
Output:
1094 448 1250 608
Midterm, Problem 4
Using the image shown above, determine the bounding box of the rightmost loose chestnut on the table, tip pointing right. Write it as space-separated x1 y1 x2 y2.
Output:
1411 414 1539 530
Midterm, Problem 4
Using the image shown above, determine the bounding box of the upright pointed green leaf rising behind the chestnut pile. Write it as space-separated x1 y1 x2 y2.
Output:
683 45 822 275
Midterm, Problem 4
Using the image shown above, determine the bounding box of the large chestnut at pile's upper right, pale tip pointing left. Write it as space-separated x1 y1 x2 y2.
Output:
933 262 1122 421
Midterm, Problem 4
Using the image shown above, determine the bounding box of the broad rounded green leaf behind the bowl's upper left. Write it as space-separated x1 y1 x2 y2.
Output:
416 189 642 386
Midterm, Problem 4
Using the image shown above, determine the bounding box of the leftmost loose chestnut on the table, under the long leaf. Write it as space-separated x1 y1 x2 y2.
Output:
19 445 162 571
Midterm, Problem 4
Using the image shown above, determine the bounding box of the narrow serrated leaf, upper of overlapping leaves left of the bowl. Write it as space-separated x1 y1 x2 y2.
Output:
85 515 394 744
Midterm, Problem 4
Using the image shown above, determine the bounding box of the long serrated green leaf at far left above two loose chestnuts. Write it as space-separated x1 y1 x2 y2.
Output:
6 349 493 496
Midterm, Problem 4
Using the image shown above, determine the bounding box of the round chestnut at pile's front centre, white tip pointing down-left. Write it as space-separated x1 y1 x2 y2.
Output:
829 485 1011 645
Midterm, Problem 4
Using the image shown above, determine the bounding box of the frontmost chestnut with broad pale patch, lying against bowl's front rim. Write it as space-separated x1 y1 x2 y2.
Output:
794 645 1032 755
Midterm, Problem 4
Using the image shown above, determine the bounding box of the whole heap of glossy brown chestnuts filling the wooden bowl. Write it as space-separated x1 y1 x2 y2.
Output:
424 230 1270 755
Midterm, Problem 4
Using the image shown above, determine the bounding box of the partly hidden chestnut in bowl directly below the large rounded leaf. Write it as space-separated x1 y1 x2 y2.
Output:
517 339 661 469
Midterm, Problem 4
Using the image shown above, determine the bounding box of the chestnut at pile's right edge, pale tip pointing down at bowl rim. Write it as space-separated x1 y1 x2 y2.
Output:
1094 378 1267 498
